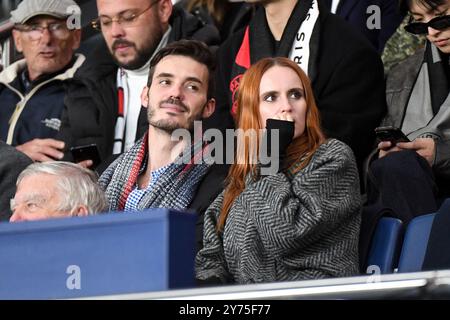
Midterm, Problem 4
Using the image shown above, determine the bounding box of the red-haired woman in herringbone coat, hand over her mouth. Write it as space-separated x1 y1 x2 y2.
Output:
196 57 361 283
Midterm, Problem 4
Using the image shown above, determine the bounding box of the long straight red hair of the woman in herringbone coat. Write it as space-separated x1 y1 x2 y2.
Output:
217 57 324 231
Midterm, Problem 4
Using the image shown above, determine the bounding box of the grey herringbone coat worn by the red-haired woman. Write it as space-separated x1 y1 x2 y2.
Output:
196 140 361 283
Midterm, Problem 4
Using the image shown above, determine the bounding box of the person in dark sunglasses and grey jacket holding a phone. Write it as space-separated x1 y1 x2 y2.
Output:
361 0 450 270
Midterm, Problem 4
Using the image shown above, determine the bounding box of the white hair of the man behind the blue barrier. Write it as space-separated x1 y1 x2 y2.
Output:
17 161 108 214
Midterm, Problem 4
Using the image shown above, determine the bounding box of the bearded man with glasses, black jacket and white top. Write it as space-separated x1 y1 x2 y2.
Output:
60 0 219 171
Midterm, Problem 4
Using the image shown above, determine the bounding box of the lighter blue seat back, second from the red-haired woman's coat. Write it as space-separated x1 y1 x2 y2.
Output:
398 213 436 272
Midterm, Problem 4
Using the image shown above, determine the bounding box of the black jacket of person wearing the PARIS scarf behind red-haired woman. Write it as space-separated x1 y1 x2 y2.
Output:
205 3 386 168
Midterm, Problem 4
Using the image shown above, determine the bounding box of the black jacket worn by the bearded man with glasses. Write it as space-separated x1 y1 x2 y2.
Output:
57 8 219 165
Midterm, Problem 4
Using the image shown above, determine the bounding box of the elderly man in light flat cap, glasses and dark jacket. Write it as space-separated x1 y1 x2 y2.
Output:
0 0 85 162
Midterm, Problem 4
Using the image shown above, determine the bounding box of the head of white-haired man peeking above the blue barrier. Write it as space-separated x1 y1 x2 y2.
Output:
9 161 108 222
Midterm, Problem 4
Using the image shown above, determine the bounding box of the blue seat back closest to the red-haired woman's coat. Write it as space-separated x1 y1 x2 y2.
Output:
367 217 403 273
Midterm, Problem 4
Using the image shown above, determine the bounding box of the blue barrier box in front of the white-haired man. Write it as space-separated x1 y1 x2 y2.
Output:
0 209 196 299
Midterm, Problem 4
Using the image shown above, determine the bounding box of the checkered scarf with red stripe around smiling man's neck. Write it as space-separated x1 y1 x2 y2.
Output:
99 132 210 211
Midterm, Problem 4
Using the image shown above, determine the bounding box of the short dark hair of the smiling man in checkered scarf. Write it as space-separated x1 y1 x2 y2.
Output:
147 40 216 100
